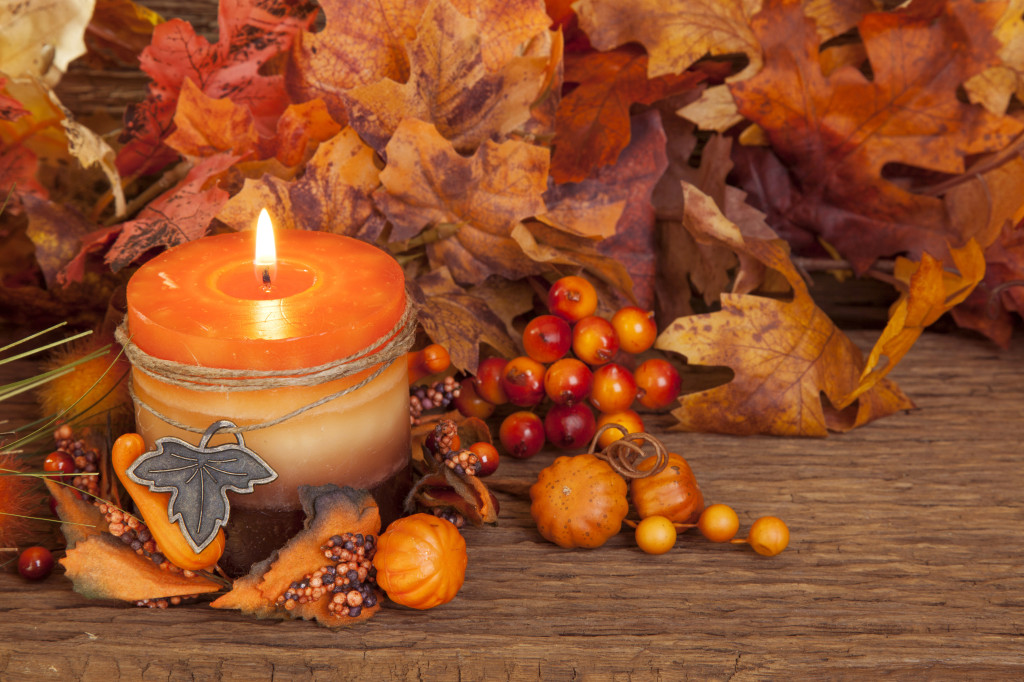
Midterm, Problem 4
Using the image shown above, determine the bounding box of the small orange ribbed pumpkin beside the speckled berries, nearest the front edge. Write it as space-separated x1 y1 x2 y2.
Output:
374 514 467 609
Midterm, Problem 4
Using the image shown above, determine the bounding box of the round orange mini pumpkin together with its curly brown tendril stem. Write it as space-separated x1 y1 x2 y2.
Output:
529 424 668 549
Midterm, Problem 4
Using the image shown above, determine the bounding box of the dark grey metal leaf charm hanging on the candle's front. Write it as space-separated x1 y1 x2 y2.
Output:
127 420 278 554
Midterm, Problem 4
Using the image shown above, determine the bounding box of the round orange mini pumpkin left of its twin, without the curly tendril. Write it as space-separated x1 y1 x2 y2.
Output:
529 454 629 548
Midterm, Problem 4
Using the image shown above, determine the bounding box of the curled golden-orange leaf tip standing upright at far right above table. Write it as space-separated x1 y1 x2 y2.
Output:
836 240 985 410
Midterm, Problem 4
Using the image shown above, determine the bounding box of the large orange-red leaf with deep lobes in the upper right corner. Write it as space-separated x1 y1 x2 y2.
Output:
729 0 1021 270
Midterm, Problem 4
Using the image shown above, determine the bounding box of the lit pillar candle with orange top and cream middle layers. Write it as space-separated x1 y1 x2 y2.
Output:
127 218 410 569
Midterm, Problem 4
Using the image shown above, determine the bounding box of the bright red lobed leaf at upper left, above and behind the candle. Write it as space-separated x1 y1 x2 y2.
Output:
118 0 315 175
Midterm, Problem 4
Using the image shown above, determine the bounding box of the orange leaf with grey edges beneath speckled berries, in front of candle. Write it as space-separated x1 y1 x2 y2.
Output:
211 484 381 627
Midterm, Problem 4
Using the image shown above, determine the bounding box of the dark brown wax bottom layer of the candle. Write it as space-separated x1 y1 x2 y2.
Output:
219 465 413 580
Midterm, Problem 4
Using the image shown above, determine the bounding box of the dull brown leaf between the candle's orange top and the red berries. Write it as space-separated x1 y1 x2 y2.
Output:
410 267 518 375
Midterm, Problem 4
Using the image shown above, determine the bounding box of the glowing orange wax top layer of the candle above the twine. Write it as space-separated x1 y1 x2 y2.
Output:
128 230 406 371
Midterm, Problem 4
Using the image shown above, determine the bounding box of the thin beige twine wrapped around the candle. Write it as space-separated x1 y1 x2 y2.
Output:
115 297 416 433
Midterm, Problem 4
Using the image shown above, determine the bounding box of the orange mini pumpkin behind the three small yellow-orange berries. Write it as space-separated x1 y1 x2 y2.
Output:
630 453 703 523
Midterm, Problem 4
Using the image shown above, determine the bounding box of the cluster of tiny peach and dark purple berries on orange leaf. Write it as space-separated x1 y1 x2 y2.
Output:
275 532 377 619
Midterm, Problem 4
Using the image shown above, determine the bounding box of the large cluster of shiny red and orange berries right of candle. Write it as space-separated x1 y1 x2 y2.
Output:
455 275 682 459
